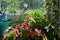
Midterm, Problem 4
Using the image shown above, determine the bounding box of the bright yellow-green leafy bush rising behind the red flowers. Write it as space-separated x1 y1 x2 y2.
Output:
27 9 47 28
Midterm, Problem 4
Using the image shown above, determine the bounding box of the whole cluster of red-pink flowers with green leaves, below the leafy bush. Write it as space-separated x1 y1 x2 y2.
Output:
4 20 43 40
